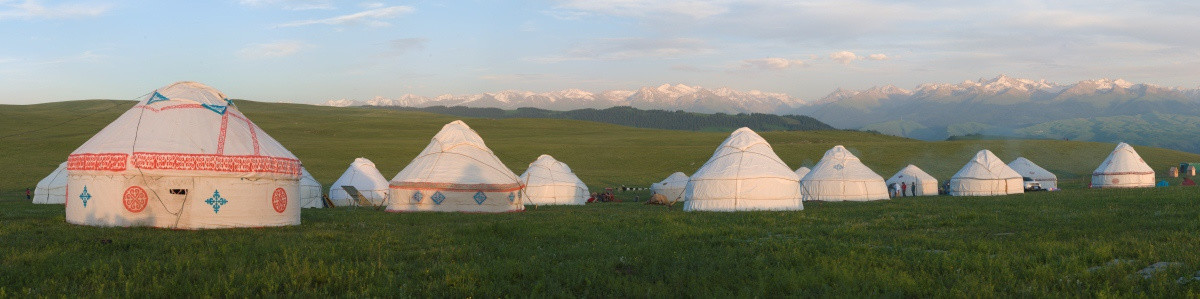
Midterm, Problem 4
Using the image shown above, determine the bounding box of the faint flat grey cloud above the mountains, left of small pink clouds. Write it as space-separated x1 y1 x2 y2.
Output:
532 37 713 62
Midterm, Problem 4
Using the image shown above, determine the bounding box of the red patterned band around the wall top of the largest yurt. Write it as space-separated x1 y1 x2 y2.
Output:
67 153 300 175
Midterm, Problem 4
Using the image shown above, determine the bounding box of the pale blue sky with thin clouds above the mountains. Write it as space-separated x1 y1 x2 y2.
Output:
0 0 1200 104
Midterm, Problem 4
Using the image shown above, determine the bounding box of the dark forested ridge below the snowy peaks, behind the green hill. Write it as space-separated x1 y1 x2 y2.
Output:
382 106 834 132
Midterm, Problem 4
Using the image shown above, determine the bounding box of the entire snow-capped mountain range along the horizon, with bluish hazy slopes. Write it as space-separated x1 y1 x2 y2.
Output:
325 74 1200 153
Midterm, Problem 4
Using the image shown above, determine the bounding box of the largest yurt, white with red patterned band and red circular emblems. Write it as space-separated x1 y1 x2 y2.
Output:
66 82 300 229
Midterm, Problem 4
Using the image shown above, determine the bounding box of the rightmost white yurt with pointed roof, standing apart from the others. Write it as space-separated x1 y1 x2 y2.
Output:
1092 142 1154 187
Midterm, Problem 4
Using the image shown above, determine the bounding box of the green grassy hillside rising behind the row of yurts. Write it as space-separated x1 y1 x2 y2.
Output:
0 101 1200 195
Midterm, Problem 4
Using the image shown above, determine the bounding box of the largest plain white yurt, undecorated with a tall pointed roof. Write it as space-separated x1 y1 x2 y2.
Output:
683 127 804 211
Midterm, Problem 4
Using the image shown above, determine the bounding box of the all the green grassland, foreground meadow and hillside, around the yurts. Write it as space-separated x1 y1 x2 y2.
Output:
0 101 1200 297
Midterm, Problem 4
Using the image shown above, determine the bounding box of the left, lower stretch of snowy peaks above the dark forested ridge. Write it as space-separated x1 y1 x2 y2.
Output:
324 84 804 113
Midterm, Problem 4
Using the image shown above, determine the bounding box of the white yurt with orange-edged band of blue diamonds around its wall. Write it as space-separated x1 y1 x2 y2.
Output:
388 120 524 213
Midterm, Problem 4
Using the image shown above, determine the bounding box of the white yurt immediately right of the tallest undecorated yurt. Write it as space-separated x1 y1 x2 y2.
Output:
800 145 888 202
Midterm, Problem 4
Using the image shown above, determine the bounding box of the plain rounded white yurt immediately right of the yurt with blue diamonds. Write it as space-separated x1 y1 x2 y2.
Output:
520 155 590 205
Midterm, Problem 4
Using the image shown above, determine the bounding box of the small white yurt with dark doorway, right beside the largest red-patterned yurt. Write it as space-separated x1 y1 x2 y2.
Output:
329 157 388 207
